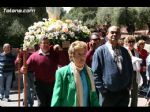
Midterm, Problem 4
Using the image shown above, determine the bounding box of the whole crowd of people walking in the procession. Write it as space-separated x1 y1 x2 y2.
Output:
0 26 150 107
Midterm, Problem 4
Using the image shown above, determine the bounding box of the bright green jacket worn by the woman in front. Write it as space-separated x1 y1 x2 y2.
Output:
51 64 99 107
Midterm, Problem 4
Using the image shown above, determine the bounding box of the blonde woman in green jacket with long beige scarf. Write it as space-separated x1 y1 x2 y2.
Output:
51 41 99 107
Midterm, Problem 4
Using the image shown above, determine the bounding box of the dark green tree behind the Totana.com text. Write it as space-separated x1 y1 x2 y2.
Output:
0 7 48 47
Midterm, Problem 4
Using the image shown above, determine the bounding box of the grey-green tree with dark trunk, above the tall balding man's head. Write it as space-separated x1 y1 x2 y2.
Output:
97 7 138 34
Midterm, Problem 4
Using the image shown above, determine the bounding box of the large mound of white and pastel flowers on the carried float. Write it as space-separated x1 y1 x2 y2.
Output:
23 18 91 49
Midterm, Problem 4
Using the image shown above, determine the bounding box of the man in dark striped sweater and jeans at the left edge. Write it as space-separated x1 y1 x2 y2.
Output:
0 43 15 101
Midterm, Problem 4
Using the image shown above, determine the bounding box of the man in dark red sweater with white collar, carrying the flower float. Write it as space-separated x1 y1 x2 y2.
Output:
22 36 58 107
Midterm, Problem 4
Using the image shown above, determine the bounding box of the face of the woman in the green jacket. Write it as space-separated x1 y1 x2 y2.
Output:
73 49 87 68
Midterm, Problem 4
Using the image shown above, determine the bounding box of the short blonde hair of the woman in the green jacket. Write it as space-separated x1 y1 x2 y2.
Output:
68 40 87 61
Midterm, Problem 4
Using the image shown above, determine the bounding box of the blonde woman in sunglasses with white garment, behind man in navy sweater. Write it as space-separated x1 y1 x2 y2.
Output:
126 36 142 107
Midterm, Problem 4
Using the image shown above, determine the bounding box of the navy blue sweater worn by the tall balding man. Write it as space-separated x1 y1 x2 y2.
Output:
92 43 133 92
